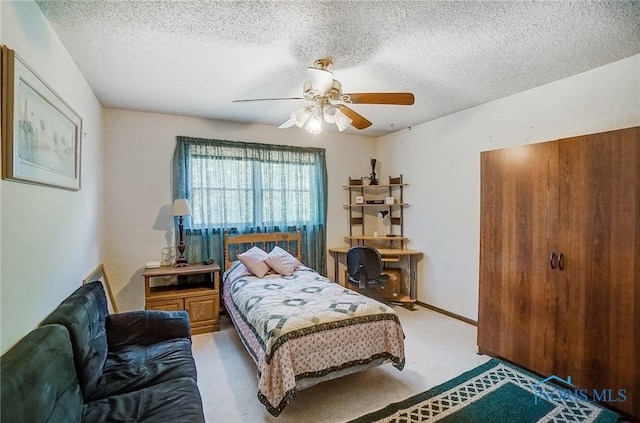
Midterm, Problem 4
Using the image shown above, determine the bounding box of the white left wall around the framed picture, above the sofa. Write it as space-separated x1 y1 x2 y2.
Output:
0 1 103 352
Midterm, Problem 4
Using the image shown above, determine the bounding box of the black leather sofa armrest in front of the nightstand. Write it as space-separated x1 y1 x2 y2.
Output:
106 310 191 348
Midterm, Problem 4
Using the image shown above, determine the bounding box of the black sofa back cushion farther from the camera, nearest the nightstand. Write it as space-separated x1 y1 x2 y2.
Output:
42 281 108 401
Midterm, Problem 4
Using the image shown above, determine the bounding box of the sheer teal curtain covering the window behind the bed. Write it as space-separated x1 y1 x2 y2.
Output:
173 136 327 275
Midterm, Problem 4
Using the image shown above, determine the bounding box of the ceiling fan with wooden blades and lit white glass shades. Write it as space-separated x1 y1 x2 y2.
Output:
233 58 415 134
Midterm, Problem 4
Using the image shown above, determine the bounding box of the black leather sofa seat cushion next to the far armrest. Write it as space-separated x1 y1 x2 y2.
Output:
92 338 197 398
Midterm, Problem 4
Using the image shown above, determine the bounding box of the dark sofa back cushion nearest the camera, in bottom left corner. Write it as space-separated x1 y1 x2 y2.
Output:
0 325 83 423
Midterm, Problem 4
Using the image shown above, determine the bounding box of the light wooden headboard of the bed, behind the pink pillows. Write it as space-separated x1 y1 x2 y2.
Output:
224 230 302 270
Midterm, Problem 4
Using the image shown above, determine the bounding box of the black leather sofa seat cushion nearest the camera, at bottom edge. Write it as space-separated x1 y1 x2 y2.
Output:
82 378 204 423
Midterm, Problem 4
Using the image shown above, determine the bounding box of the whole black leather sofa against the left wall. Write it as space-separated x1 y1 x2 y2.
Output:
0 282 204 423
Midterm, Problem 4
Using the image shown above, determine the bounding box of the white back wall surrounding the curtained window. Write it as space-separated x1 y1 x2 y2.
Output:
105 109 376 310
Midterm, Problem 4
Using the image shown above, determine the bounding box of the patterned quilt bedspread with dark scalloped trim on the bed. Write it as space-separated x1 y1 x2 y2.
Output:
223 262 405 416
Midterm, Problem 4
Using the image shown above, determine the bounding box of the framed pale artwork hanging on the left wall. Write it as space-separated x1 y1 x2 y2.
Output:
0 46 82 191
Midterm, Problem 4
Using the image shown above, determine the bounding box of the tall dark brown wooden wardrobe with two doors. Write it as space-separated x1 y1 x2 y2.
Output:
478 127 640 418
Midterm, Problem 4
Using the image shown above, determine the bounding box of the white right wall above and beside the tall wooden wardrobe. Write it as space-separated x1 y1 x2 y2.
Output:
377 55 640 320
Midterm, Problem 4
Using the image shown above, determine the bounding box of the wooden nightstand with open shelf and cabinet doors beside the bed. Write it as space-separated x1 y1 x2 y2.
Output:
142 263 220 335
